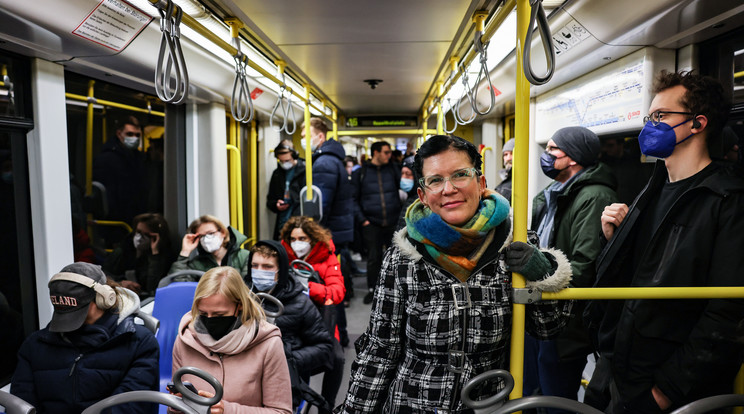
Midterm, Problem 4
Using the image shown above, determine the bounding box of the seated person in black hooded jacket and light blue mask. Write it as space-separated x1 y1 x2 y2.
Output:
245 240 333 406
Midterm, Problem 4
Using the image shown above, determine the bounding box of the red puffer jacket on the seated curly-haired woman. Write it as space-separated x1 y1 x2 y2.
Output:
282 240 346 305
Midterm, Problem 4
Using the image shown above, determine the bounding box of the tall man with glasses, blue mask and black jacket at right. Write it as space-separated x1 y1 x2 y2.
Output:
585 72 744 414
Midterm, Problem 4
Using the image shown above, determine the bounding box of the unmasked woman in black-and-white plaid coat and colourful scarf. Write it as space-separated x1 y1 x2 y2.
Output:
340 135 571 413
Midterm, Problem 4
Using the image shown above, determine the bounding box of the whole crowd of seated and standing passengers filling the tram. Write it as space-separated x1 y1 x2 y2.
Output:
5 72 744 414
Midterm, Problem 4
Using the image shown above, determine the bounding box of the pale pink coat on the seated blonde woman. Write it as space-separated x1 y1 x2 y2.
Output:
173 312 292 414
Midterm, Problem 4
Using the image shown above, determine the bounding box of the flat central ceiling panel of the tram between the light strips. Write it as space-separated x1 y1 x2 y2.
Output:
206 0 482 115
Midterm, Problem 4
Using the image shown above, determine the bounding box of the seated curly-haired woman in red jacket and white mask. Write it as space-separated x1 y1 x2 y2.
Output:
280 216 346 306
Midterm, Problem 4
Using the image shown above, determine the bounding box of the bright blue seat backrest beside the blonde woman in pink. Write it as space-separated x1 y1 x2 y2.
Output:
152 282 197 392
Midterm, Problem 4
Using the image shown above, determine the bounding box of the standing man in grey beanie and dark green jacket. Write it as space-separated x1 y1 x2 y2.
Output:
524 127 618 414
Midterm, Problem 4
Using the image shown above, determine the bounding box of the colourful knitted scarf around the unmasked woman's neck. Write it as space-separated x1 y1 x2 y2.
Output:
406 190 509 282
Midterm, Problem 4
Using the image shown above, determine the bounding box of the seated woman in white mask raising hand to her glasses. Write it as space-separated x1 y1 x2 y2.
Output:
168 215 248 277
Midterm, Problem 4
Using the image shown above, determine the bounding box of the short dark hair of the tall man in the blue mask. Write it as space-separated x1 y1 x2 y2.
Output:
653 70 731 139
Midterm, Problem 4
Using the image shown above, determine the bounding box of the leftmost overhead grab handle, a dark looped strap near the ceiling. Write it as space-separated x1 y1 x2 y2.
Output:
154 0 189 104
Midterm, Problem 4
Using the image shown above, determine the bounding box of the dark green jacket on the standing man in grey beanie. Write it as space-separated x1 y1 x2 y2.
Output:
532 163 618 287
